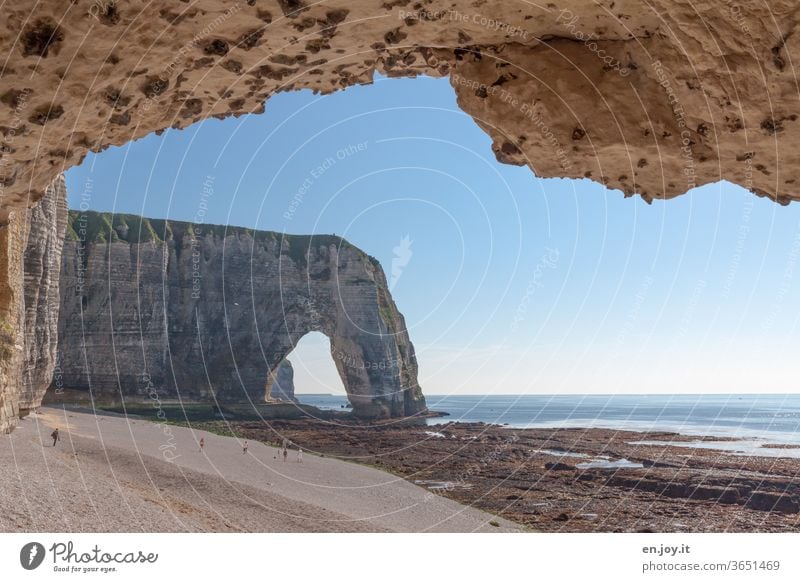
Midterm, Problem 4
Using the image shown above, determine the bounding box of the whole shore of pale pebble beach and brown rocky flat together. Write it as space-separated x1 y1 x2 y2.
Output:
10 407 800 532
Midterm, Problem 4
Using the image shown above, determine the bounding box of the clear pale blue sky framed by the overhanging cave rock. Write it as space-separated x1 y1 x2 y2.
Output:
67 78 800 394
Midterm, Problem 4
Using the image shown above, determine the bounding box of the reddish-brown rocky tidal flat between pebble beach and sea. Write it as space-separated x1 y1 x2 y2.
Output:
202 419 800 532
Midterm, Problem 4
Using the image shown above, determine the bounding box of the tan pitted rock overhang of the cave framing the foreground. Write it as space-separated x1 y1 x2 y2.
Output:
0 0 800 429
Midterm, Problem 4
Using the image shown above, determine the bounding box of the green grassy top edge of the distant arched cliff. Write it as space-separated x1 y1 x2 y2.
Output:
66 210 380 268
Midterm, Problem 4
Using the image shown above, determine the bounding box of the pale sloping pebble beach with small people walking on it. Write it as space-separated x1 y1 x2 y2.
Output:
0 407 522 532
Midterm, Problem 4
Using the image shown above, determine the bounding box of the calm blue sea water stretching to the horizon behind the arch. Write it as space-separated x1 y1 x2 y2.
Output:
299 394 800 444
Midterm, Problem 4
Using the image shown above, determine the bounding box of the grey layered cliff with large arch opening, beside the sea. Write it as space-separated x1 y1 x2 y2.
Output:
59 212 425 417
